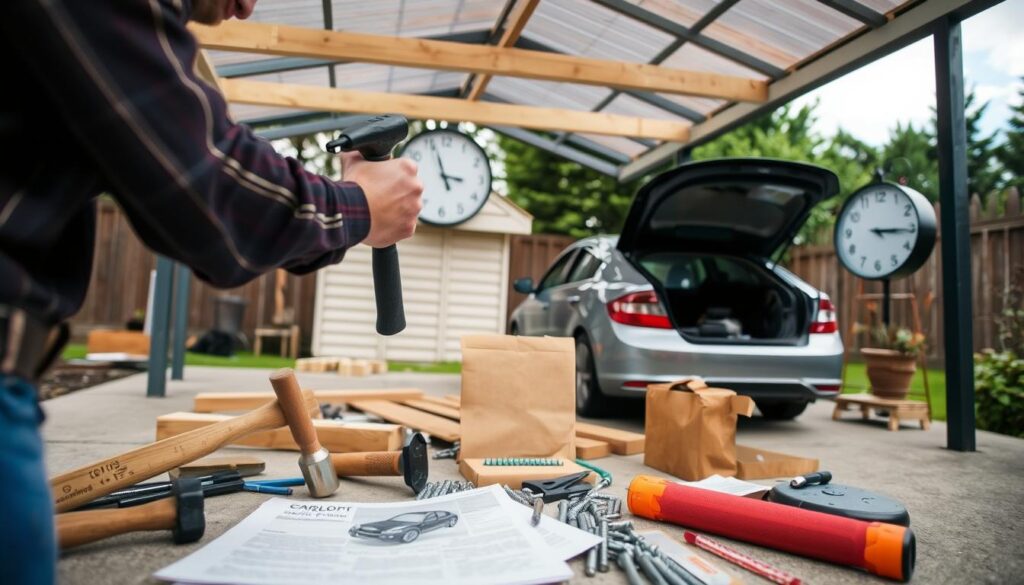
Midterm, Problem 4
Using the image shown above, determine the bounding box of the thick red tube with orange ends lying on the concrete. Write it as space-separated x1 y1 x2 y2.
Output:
628 475 915 581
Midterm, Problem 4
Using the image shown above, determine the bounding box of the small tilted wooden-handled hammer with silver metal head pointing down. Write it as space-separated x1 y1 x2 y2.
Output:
270 368 338 498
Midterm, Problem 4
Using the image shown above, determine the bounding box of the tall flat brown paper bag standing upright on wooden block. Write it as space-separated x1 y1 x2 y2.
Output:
459 335 575 459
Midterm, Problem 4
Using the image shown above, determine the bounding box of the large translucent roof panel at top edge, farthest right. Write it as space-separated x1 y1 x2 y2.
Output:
703 0 864 69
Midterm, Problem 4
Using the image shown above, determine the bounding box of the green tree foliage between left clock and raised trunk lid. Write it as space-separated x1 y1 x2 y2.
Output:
498 135 640 238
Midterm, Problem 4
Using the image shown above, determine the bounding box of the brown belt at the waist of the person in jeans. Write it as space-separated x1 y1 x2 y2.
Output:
0 304 69 382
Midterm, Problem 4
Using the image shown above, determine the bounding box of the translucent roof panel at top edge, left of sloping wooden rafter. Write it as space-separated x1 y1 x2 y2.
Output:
331 0 503 37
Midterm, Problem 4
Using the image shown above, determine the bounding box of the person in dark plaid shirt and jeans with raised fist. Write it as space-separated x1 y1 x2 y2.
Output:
0 0 423 585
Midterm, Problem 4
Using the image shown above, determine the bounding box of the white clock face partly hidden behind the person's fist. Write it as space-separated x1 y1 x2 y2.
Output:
401 130 490 225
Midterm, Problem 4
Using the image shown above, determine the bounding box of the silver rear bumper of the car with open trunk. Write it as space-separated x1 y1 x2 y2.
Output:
594 325 843 402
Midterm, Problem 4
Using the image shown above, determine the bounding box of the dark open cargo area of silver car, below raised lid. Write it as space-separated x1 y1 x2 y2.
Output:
637 252 813 345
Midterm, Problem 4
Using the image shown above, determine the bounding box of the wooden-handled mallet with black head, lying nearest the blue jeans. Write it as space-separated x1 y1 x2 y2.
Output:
56 477 206 550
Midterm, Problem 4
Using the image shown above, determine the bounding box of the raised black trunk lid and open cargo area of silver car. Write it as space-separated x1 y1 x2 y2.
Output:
616 159 839 344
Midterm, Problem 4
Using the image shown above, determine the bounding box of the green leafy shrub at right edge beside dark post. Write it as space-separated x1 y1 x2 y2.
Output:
974 350 1024 437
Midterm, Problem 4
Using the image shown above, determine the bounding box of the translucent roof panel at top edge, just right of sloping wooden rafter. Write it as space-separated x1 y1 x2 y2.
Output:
522 0 674 62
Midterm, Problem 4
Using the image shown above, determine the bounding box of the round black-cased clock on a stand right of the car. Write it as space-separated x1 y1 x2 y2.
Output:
835 183 935 280
